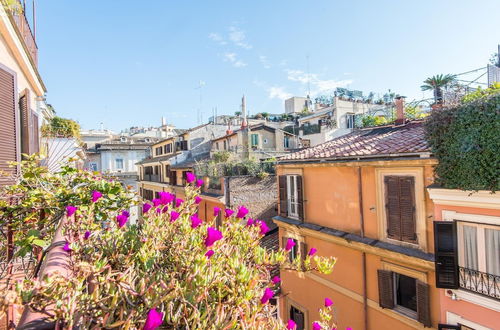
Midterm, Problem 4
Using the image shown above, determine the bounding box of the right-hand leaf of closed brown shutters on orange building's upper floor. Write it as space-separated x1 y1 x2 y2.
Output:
399 176 417 243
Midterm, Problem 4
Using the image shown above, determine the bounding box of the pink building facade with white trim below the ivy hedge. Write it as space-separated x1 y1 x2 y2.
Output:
428 187 500 330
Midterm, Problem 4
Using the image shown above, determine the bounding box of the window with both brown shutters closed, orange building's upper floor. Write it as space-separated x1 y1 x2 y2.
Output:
384 176 417 243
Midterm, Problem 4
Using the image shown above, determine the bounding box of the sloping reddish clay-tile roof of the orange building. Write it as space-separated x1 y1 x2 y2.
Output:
279 120 430 162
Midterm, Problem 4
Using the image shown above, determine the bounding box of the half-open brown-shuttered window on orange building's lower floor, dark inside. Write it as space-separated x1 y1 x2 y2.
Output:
377 269 432 327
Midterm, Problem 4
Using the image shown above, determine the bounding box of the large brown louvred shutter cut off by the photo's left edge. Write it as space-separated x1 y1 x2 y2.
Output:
0 69 18 186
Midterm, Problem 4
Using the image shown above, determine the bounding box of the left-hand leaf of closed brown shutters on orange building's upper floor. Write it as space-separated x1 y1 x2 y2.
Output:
384 176 401 240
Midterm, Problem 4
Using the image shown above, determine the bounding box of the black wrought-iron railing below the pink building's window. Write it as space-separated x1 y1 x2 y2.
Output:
459 267 500 300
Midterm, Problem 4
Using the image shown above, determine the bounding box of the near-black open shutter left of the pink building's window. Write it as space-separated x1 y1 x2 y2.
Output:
434 221 459 289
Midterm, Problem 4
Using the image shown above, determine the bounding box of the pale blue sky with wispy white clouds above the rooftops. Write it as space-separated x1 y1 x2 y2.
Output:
33 0 500 131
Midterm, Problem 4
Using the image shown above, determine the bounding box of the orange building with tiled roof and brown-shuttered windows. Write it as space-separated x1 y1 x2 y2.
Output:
274 122 440 329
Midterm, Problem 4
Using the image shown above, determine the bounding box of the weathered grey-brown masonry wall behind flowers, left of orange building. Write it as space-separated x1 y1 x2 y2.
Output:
225 175 278 225
